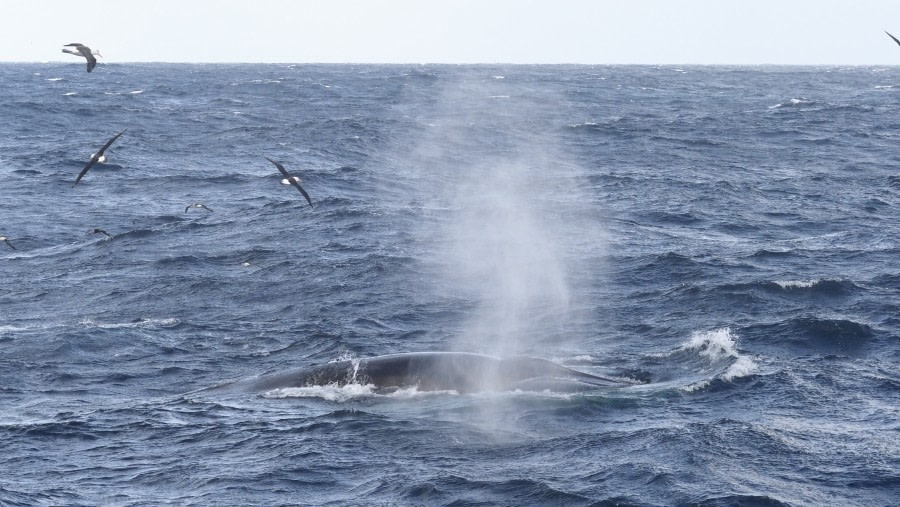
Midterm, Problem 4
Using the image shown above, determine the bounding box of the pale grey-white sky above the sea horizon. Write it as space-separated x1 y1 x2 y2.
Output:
0 0 900 65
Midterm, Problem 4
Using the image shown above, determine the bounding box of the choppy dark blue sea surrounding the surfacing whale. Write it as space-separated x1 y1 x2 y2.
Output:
0 63 900 507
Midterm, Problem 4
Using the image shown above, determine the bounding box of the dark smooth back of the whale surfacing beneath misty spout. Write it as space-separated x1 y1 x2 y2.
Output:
222 352 632 394
